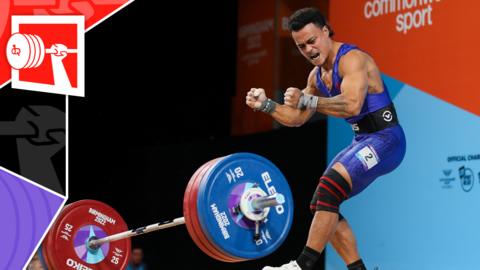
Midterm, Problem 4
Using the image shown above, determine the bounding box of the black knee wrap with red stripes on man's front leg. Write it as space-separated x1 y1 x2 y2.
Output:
310 169 351 213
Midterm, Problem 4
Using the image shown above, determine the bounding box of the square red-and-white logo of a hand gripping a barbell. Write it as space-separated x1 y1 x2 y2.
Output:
6 16 85 96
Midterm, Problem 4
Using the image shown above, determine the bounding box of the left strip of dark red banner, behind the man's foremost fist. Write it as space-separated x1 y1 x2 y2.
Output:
232 0 276 135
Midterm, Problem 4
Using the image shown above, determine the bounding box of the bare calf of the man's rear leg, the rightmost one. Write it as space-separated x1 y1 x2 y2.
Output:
330 219 360 265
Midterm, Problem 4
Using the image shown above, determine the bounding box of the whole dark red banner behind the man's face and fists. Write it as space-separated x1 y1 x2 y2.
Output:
232 0 328 135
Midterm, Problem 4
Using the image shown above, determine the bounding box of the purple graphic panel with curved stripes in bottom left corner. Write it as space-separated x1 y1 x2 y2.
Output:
0 168 64 269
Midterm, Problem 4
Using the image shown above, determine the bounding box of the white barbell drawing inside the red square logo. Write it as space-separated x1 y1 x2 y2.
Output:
6 33 77 70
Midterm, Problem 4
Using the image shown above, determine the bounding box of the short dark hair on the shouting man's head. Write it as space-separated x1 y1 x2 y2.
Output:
288 7 334 37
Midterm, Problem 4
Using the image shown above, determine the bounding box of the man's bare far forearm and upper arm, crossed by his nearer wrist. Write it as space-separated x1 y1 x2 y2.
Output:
271 67 318 127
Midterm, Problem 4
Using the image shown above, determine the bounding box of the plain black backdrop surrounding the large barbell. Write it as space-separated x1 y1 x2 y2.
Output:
64 0 326 269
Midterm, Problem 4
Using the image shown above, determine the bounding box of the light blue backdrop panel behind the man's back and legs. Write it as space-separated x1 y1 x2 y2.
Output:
326 76 480 270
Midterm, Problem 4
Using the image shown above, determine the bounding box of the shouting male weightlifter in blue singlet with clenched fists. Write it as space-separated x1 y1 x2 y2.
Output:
246 8 406 270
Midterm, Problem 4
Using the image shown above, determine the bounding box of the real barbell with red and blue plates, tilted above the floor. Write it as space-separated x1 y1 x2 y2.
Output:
39 153 293 270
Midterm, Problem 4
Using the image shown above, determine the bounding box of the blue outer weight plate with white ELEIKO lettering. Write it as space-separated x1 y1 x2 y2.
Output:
197 153 293 260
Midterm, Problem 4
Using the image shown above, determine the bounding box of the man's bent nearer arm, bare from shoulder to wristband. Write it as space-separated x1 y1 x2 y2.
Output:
317 51 368 118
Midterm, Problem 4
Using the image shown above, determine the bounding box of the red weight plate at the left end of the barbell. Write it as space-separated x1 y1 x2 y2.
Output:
43 200 130 270
